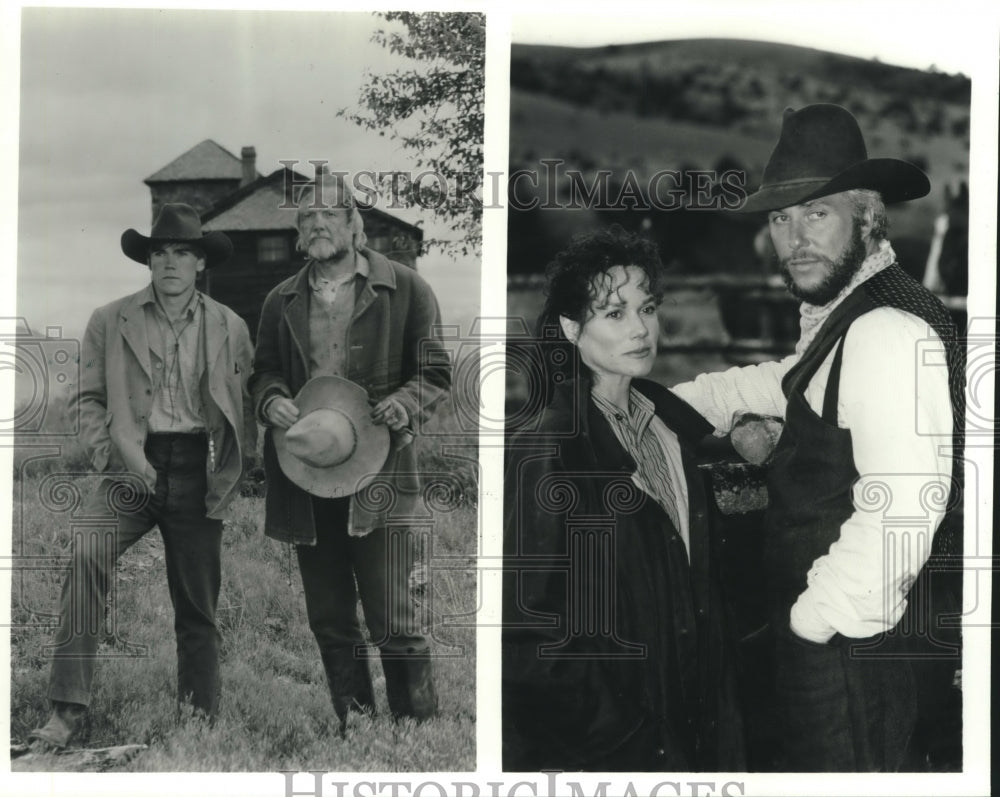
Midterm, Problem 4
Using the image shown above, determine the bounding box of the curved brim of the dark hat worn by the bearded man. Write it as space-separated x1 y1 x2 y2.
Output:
736 158 931 213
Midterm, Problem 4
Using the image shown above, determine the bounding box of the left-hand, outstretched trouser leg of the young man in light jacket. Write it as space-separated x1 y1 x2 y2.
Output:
48 479 155 706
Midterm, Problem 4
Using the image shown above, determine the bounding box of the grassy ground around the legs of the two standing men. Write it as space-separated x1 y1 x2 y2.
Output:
10 404 478 772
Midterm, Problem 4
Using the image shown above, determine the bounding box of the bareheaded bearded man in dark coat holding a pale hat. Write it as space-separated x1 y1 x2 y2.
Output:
250 174 451 732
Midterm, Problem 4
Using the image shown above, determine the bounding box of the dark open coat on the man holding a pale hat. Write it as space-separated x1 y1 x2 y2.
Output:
250 249 451 545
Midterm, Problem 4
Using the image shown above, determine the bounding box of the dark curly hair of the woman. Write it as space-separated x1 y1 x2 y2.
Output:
536 224 663 404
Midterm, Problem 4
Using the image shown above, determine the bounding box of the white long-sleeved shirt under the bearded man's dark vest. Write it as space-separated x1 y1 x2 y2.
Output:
674 307 952 642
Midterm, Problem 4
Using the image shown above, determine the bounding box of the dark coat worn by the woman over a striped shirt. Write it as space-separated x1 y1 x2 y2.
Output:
502 380 744 771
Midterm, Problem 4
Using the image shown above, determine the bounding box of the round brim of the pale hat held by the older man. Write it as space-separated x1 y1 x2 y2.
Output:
274 376 389 498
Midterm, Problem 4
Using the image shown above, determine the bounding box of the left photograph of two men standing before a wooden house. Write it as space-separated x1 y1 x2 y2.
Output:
3 8 485 776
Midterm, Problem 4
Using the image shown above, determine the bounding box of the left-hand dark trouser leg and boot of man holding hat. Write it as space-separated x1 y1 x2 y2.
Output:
296 498 375 727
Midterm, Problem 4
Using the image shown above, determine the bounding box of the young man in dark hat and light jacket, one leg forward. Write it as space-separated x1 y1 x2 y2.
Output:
31 204 256 748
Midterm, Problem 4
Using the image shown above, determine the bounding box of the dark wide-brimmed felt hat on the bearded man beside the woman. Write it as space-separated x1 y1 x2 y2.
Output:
738 103 931 213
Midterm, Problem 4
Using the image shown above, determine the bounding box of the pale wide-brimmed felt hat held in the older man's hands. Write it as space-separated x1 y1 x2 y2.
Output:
274 376 389 498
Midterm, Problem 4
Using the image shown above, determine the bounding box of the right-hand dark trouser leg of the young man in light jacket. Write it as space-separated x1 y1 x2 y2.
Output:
160 438 222 717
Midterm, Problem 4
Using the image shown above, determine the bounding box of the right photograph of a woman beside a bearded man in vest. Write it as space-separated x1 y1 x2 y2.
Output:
501 4 996 794
